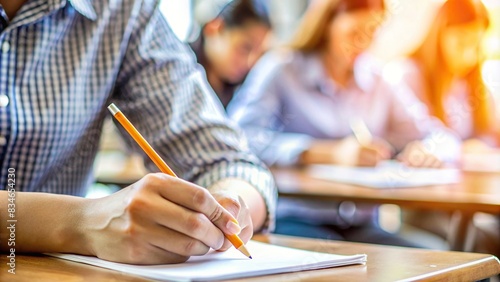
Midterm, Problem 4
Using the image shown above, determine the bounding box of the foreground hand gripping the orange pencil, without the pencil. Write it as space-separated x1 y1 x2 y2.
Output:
82 173 240 264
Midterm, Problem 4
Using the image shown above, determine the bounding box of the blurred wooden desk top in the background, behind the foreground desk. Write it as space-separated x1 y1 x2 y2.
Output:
272 168 500 214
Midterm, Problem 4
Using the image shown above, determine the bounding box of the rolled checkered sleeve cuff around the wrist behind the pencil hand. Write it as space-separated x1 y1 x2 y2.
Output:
195 162 278 232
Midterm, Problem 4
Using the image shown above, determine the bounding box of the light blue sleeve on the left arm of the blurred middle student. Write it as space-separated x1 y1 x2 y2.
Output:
227 51 312 165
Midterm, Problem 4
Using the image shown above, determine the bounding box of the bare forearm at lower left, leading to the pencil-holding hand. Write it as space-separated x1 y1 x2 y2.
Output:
0 191 90 254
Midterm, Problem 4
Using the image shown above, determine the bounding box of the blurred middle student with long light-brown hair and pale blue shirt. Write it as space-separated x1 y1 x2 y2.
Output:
228 0 458 245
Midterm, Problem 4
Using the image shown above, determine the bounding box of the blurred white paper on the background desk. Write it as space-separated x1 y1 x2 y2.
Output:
308 161 461 188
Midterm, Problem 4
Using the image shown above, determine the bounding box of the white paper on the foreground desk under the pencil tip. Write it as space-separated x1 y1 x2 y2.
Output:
48 241 367 281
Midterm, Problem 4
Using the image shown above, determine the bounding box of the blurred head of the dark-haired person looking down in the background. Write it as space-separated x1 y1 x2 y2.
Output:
190 0 271 108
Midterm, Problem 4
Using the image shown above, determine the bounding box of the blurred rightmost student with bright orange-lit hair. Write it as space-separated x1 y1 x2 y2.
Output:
401 0 500 150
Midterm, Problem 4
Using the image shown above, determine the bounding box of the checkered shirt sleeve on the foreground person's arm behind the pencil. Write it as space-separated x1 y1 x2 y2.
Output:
113 1 277 229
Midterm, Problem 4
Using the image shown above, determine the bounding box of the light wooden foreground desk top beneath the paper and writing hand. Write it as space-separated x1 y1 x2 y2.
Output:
0 235 500 282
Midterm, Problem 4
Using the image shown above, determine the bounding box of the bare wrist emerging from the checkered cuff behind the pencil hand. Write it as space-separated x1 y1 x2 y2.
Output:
208 178 267 231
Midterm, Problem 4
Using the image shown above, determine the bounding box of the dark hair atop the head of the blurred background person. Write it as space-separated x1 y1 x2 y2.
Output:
217 0 271 28
